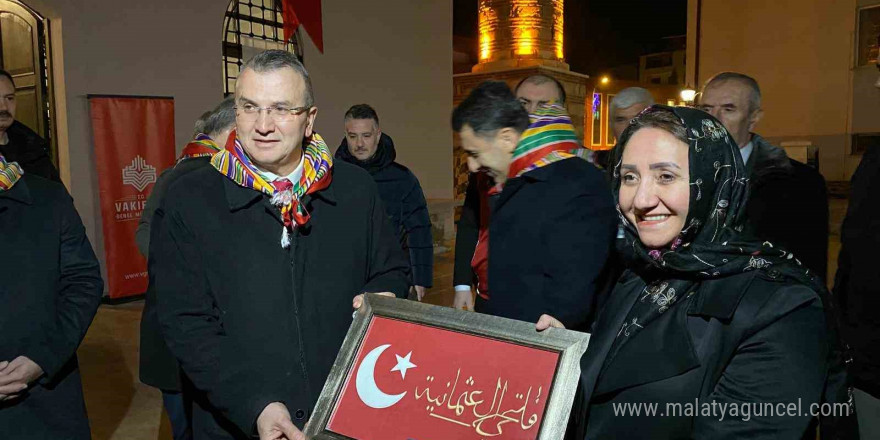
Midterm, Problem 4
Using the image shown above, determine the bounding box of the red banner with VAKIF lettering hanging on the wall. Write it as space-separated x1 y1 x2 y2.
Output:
89 96 175 298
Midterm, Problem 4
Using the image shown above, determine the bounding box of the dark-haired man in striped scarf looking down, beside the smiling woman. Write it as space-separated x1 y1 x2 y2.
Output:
452 81 617 328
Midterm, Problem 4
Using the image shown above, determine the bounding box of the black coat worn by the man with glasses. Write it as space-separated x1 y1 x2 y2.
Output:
149 162 409 438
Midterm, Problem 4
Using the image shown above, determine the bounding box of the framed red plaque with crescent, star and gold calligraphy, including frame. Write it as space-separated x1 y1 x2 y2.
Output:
305 294 590 440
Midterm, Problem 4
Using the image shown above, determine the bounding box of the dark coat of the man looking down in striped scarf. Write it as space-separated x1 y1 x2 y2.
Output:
475 158 617 328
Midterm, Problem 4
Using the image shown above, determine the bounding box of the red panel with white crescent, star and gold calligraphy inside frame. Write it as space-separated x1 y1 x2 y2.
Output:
326 316 559 440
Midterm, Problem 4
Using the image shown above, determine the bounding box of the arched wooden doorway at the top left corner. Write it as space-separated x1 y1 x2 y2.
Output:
0 0 52 163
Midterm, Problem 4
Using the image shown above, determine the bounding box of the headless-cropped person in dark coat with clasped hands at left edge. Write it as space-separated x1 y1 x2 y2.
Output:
0 156 104 440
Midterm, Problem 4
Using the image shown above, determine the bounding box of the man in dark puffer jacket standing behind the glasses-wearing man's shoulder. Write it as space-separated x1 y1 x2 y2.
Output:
335 104 434 301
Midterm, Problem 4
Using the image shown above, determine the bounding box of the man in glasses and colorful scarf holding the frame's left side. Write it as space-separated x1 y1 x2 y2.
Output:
150 50 409 440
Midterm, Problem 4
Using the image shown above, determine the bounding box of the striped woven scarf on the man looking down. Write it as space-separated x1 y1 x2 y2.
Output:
507 105 591 179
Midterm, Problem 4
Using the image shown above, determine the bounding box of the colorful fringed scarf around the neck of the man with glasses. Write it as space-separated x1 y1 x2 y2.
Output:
211 132 333 248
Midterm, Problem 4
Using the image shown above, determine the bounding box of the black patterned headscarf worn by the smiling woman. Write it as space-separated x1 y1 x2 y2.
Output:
612 105 824 351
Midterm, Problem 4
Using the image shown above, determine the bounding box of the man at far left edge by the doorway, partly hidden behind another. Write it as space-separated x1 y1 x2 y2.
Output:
0 70 61 182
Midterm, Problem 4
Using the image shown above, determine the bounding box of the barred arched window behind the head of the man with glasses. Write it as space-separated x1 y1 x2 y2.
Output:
223 0 302 95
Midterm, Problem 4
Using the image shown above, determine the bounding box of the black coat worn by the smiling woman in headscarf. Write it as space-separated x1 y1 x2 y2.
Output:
572 269 829 440
